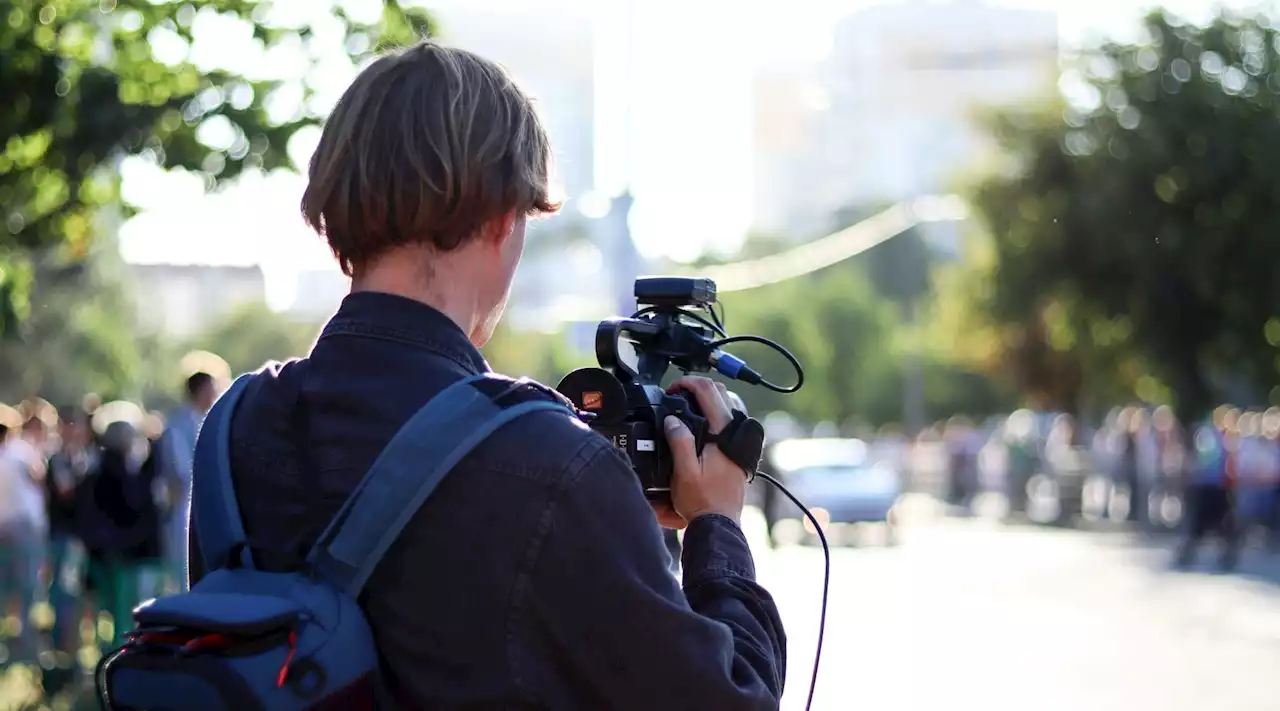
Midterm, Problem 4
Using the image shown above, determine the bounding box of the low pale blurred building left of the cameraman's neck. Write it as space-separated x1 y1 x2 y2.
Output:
129 264 266 338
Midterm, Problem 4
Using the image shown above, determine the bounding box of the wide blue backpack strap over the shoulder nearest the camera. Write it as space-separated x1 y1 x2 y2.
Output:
307 374 573 598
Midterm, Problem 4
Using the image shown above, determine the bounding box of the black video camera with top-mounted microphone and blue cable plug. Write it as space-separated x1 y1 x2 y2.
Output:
556 277 804 501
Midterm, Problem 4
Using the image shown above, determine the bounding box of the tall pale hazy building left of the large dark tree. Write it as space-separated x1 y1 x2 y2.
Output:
762 0 1059 237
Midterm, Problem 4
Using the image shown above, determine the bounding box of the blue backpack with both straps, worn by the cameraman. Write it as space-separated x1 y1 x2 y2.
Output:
95 374 575 711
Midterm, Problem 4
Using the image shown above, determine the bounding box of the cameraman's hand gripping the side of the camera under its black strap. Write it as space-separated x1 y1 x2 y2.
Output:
654 377 748 528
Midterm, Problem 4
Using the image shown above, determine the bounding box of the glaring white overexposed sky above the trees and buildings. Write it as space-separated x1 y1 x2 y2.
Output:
120 0 1254 305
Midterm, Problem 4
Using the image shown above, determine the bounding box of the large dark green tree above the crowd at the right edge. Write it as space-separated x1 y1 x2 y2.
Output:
970 12 1280 415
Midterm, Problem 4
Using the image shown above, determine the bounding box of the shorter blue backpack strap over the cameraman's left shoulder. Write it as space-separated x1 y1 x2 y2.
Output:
191 373 255 571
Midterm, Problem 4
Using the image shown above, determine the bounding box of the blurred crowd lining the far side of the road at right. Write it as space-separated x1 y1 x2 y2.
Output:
910 405 1280 565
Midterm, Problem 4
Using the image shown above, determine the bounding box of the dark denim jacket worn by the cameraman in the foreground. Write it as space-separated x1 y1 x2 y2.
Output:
191 292 786 711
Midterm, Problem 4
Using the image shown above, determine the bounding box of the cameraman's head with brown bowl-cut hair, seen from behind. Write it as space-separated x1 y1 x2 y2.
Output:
302 42 558 346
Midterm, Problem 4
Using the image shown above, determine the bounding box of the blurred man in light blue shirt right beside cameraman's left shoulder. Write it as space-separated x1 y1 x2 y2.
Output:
156 373 219 589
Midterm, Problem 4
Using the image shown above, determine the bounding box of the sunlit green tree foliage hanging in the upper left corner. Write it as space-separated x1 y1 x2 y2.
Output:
0 0 433 333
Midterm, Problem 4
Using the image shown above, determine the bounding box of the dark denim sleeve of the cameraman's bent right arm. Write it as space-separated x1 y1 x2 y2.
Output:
525 442 786 711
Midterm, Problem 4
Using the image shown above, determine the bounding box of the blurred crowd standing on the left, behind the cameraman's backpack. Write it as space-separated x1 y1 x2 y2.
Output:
0 373 220 666
